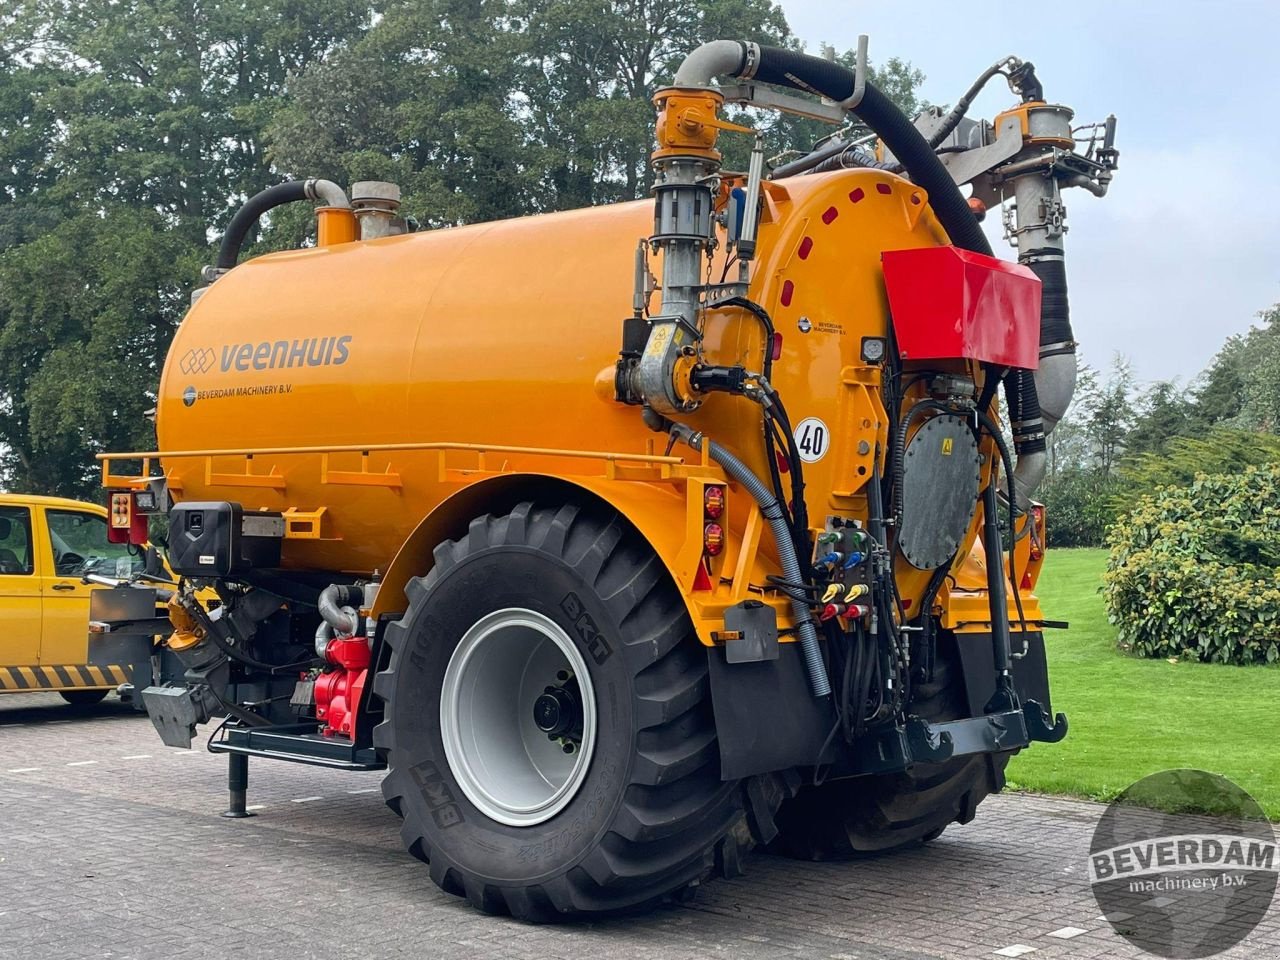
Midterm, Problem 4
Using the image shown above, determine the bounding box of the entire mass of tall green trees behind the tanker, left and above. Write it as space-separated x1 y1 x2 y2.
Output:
0 0 923 497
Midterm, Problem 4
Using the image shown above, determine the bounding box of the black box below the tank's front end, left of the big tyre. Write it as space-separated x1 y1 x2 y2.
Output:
169 502 284 577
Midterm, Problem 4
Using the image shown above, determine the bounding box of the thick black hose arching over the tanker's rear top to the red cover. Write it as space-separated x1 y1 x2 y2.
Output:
754 46 991 256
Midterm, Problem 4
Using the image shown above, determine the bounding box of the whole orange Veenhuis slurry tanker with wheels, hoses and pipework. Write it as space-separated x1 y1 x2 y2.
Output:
97 41 1117 920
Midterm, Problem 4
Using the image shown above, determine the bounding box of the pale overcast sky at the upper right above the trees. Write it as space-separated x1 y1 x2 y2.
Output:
781 0 1280 381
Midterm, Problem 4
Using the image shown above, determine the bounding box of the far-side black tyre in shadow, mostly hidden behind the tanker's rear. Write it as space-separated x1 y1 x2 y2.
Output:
771 636 1011 860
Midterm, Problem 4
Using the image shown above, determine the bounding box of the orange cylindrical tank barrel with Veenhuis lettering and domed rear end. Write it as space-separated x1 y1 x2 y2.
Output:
156 170 946 571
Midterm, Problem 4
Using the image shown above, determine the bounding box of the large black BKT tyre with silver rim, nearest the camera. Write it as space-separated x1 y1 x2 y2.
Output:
374 503 796 922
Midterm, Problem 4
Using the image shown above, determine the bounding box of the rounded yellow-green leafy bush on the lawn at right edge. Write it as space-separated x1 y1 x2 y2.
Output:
1103 463 1280 664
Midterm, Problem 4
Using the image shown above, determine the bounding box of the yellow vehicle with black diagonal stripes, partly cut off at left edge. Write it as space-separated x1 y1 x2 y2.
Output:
0 493 143 704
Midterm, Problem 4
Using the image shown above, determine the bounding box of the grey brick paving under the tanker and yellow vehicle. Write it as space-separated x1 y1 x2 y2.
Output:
0 695 1280 960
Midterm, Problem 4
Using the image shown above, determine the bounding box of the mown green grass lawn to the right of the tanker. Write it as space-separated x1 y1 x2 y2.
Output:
1009 549 1280 820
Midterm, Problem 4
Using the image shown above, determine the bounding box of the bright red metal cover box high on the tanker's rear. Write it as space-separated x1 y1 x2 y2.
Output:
881 247 1041 370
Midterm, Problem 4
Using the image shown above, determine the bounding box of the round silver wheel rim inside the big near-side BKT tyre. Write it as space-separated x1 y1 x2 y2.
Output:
440 607 596 827
